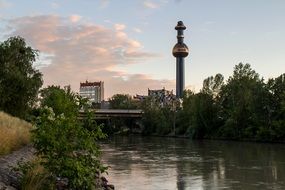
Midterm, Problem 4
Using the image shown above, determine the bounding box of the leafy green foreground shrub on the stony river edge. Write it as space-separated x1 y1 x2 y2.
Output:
33 107 106 189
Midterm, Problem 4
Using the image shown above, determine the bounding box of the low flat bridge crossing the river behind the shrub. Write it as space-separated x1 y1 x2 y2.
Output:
79 109 143 119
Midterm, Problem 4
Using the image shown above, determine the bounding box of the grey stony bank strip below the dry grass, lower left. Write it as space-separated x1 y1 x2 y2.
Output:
0 145 35 190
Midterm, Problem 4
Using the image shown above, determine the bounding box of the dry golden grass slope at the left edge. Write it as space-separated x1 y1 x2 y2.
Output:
0 112 33 155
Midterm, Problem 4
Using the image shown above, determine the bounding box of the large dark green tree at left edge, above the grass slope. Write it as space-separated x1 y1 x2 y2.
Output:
0 37 43 118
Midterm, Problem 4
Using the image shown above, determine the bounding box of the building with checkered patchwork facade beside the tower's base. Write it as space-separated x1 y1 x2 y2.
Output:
148 88 176 107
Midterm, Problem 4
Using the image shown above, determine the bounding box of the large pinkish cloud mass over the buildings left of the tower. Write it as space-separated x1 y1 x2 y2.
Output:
6 15 170 97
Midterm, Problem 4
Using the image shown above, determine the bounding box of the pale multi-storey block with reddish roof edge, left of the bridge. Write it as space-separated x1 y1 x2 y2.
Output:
79 81 104 105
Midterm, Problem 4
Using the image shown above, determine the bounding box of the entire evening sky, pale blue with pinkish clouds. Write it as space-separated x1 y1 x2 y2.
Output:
0 0 285 99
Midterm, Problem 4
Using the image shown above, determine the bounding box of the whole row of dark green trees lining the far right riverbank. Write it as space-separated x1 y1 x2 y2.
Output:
142 63 285 141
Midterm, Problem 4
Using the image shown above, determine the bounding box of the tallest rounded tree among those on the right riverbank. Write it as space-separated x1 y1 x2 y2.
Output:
217 63 266 138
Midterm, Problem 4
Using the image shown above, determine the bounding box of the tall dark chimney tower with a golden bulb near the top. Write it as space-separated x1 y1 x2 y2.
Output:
172 21 189 98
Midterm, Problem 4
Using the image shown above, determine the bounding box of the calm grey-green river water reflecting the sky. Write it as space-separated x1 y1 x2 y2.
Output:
101 136 285 190
